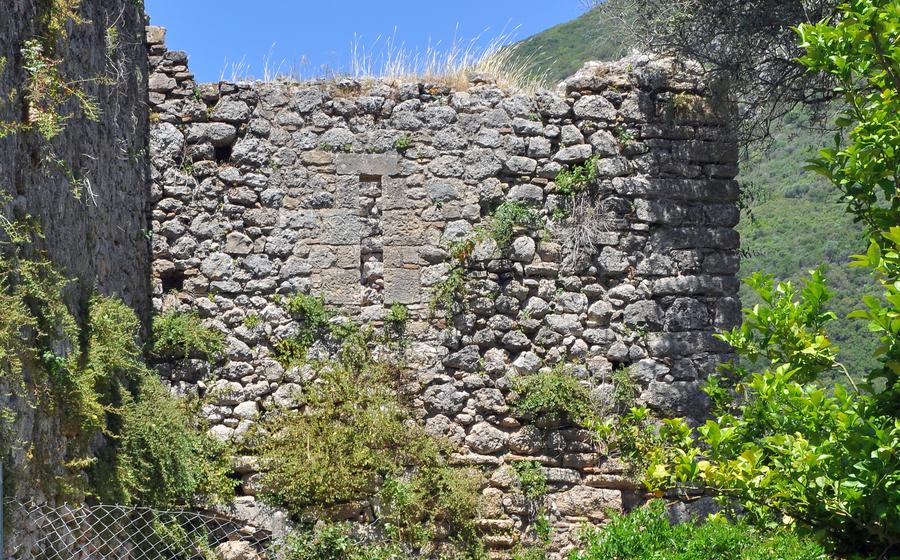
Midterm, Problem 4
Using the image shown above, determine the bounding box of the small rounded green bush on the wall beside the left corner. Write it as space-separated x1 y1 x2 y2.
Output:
152 311 225 361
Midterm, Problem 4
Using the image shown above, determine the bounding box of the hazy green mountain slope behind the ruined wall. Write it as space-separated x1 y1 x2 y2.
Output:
515 10 875 375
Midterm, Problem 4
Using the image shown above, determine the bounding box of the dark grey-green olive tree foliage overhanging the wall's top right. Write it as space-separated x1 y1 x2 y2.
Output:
588 0 839 145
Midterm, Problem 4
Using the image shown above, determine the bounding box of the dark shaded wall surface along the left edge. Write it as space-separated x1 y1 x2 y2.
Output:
0 0 150 558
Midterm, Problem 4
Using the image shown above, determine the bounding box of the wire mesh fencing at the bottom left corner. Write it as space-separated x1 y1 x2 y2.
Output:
5 500 282 560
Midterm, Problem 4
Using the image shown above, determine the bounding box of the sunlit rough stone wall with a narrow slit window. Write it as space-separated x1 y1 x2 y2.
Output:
148 27 739 548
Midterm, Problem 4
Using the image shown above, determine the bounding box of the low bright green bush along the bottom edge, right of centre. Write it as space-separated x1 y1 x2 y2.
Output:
569 500 828 560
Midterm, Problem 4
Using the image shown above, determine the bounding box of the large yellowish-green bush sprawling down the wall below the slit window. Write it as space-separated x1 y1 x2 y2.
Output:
250 329 480 558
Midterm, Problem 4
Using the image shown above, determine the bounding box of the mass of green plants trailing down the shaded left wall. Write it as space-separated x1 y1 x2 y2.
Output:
0 209 232 506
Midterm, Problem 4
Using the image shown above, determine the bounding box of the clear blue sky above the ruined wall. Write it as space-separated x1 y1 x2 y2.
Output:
146 0 583 82
